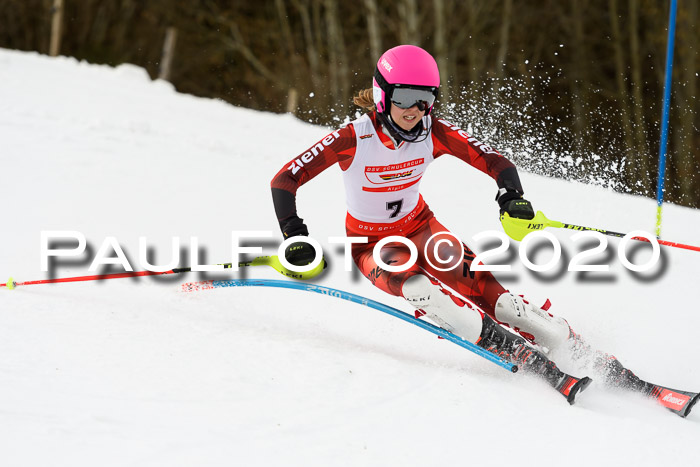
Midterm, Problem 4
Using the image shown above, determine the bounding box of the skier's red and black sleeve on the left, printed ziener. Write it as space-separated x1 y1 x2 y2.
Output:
271 125 356 238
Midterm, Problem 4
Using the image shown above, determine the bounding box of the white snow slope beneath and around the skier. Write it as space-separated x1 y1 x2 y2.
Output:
0 50 700 466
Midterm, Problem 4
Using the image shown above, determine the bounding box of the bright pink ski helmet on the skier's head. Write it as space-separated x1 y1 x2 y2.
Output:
372 45 440 115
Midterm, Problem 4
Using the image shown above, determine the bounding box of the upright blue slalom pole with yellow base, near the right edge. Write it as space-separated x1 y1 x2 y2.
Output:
656 0 677 238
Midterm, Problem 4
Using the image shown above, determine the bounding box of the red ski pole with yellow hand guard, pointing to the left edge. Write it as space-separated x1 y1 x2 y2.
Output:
0 256 324 289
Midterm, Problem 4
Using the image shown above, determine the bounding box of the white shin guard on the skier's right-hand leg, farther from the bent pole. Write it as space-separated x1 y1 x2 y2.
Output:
494 292 571 350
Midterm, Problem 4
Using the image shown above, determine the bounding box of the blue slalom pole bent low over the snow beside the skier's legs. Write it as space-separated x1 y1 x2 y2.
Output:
182 279 518 373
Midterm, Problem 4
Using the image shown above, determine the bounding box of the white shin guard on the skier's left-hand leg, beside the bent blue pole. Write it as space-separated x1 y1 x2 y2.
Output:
401 274 483 342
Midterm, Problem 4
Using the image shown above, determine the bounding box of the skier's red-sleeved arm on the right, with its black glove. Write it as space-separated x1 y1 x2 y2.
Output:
431 117 534 219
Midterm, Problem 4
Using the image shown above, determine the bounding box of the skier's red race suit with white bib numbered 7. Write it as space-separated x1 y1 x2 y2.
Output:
272 112 522 316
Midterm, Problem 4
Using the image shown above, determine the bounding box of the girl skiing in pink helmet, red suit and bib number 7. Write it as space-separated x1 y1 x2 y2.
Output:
272 45 660 402
